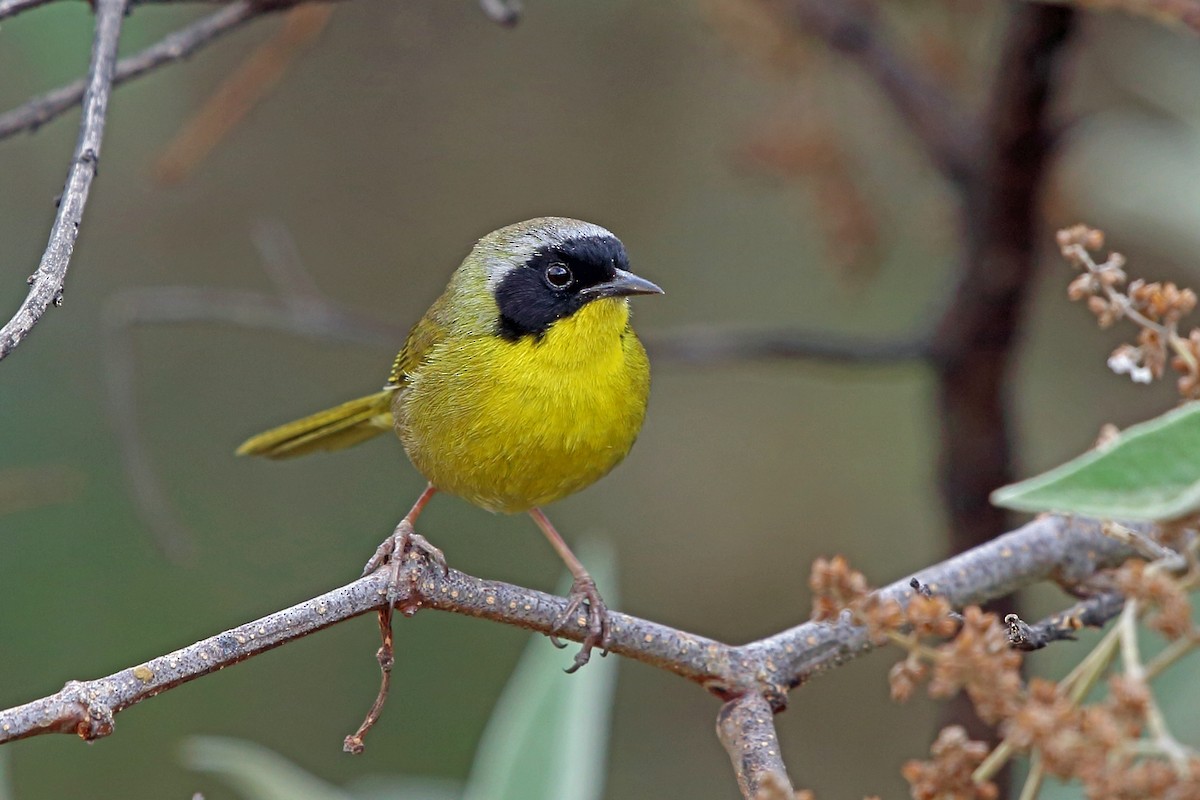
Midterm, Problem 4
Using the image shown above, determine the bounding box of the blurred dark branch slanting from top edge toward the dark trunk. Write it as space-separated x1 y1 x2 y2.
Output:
769 0 979 184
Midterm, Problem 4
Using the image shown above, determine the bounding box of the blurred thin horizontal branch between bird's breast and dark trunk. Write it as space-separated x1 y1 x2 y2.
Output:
646 329 929 366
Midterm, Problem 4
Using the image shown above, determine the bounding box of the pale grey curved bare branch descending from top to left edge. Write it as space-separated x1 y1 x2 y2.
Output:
0 0 125 359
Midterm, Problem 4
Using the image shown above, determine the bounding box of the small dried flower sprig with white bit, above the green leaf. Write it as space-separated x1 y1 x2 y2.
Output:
1057 225 1200 399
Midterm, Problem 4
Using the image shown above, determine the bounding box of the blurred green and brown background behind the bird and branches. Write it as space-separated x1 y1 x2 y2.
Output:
0 0 1200 800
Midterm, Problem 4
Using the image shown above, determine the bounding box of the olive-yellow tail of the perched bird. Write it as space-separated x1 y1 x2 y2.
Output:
238 389 395 458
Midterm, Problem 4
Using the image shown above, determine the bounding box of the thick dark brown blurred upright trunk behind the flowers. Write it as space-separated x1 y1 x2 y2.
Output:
932 2 1074 552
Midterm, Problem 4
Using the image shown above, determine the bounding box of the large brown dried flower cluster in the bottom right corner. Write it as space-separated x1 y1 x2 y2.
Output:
810 557 1200 800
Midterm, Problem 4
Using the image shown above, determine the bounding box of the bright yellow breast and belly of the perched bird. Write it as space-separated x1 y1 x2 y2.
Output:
392 299 650 513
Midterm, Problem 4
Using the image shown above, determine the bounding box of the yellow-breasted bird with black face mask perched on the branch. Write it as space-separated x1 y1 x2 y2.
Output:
236 217 662 672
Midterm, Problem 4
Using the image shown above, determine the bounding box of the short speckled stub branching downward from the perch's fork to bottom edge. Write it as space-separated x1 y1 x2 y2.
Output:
716 694 796 800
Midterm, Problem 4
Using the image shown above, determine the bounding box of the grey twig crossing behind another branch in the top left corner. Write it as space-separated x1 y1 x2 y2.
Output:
0 0 270 139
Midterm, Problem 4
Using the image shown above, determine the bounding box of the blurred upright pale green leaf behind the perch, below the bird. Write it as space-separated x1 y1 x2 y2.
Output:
463 534 617 800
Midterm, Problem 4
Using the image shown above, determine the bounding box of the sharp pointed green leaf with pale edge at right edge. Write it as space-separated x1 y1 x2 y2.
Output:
991 402 1200 522
